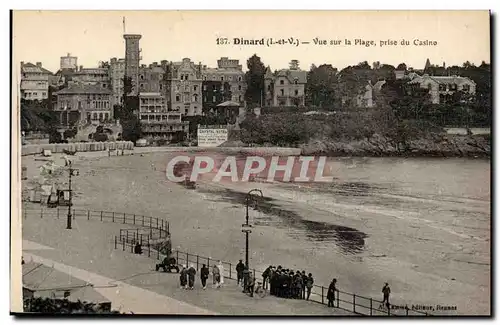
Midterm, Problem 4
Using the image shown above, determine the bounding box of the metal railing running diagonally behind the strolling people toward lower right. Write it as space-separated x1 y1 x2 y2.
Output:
114 236 430 316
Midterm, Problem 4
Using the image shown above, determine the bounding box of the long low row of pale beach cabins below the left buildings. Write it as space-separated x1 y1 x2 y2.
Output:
21 141 134 156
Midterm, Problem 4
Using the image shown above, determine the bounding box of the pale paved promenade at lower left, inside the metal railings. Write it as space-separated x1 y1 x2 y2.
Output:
23 210 348 316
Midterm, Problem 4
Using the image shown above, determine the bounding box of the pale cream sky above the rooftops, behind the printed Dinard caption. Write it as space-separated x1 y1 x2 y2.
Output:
13 10 490 72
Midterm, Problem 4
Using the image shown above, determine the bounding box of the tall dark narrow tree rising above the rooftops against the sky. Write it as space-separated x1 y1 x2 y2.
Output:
245 54 266 107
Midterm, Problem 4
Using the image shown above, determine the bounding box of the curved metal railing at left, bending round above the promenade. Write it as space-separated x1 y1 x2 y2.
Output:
21 206 170 240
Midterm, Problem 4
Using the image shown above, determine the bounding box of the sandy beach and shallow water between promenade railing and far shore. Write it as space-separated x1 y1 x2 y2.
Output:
22 152 491 315
